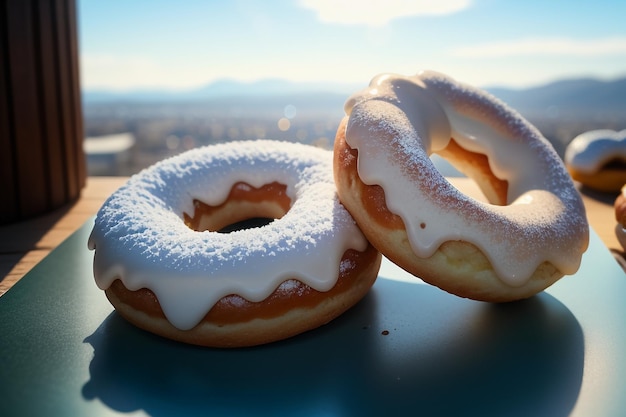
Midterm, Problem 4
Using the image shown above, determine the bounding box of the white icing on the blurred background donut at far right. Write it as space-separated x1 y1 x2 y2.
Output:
564 129 626 174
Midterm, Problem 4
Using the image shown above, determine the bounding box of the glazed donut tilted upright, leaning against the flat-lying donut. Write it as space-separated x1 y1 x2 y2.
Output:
334 71 589 302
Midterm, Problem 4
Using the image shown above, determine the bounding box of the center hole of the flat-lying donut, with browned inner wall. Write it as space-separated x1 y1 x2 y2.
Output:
184 182 291 233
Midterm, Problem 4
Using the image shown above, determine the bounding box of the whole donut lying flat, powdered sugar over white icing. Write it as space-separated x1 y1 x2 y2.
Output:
88 140 381 347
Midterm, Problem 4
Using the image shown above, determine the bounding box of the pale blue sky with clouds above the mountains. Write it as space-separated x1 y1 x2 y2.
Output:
78 0 626 90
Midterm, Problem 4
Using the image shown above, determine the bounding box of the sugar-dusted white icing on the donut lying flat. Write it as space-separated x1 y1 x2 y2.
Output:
88 140 367 329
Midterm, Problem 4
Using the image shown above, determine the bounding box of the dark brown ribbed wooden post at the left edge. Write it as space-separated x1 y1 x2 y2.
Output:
0 0 86 224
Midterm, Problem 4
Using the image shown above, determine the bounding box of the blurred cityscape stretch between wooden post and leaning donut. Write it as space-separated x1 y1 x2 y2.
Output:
83 98 343 176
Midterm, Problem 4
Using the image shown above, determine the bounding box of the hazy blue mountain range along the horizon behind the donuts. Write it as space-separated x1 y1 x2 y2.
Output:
83 78 626 118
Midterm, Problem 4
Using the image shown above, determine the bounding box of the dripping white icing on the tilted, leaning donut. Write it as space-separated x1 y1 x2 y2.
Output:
345 71 589 286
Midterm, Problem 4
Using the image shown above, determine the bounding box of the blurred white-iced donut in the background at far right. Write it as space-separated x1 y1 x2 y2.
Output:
564 129 626 193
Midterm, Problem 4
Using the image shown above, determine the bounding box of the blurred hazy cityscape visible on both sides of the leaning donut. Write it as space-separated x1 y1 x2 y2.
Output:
83 78 626 176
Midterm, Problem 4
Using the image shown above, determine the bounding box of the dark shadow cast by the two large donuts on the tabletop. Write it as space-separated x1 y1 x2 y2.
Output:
83 279 584 417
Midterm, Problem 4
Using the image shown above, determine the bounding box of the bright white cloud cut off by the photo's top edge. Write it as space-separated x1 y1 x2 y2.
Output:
300 0 471 26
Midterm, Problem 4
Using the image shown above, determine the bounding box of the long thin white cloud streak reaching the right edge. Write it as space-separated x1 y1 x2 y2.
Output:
454 37 626 58
